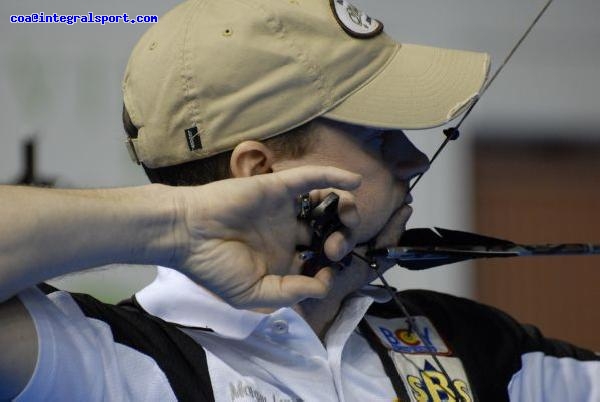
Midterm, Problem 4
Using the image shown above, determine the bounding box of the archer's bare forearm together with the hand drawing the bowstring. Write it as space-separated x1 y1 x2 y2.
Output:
0 166 360 308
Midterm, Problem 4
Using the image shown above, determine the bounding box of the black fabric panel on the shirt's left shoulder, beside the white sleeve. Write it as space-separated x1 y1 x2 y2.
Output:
38 284 215 402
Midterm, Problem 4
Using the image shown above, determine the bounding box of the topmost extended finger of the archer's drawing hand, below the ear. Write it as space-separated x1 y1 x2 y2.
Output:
275 166 362 194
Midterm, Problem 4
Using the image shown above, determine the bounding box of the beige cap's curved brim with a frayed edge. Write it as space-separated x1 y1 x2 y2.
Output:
323 44 490 129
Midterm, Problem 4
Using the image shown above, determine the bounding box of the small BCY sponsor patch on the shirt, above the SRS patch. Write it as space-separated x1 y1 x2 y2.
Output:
365 316 452 355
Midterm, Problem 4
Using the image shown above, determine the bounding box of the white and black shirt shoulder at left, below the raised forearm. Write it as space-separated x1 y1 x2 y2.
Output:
21 285 214 401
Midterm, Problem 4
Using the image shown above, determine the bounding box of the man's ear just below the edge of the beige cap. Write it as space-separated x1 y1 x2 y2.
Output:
229 141 274 177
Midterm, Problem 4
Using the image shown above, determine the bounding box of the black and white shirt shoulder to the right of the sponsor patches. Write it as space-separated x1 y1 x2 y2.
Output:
368 290 600 401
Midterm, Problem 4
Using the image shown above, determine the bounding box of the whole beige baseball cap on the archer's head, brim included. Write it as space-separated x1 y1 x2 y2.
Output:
123 0 489 168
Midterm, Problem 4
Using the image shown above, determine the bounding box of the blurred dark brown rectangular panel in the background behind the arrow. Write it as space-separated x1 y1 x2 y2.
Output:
473 135 600 351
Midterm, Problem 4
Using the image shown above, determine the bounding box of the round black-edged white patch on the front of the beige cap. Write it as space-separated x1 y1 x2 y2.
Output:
329 0 383 39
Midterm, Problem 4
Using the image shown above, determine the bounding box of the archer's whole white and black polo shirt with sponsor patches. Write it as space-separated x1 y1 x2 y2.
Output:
17 268 600 402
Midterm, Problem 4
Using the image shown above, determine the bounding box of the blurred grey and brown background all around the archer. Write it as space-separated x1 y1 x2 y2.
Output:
0 0 600 350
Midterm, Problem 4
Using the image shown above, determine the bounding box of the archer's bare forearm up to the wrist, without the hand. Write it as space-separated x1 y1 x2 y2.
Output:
0 185 178 301
